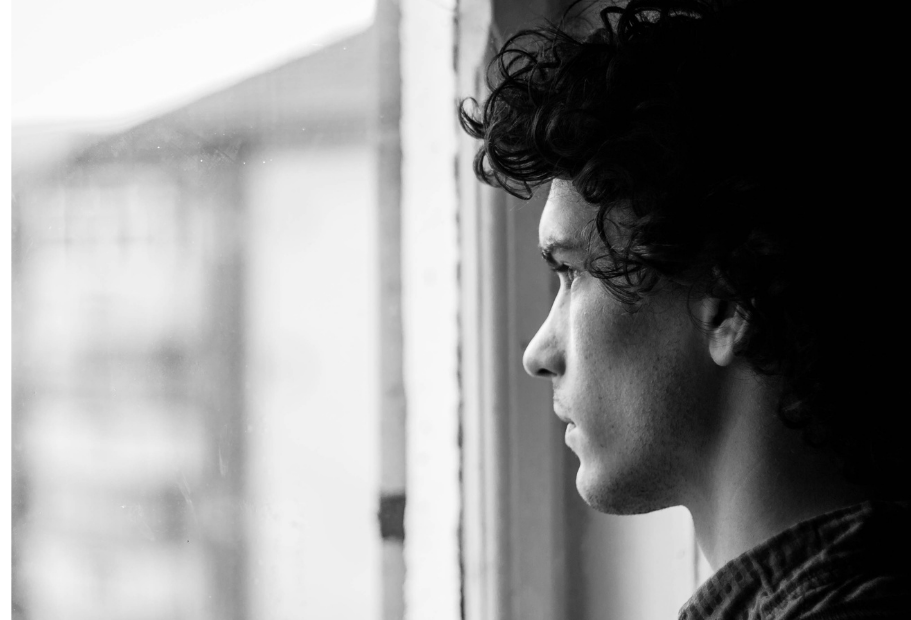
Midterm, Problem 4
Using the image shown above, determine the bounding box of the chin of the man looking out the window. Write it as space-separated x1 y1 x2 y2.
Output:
576 464 676 515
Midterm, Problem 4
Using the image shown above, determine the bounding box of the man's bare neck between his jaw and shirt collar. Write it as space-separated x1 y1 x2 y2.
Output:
686 367 866 570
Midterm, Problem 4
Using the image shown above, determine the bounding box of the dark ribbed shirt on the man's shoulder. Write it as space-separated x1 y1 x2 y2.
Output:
679 502 911 620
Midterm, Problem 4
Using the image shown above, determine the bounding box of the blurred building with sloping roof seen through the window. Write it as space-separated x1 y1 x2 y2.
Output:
13 30 380 620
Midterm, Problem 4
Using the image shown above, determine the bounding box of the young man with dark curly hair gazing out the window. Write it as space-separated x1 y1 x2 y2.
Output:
462 0 911 620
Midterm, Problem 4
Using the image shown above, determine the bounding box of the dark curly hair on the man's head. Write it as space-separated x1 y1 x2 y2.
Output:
460 0 904 492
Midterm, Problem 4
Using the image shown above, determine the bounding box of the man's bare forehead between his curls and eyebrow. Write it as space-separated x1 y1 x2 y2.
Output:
538 179 598 248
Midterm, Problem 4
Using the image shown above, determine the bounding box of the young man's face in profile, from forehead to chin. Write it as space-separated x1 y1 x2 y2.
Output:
523 180 718 514
